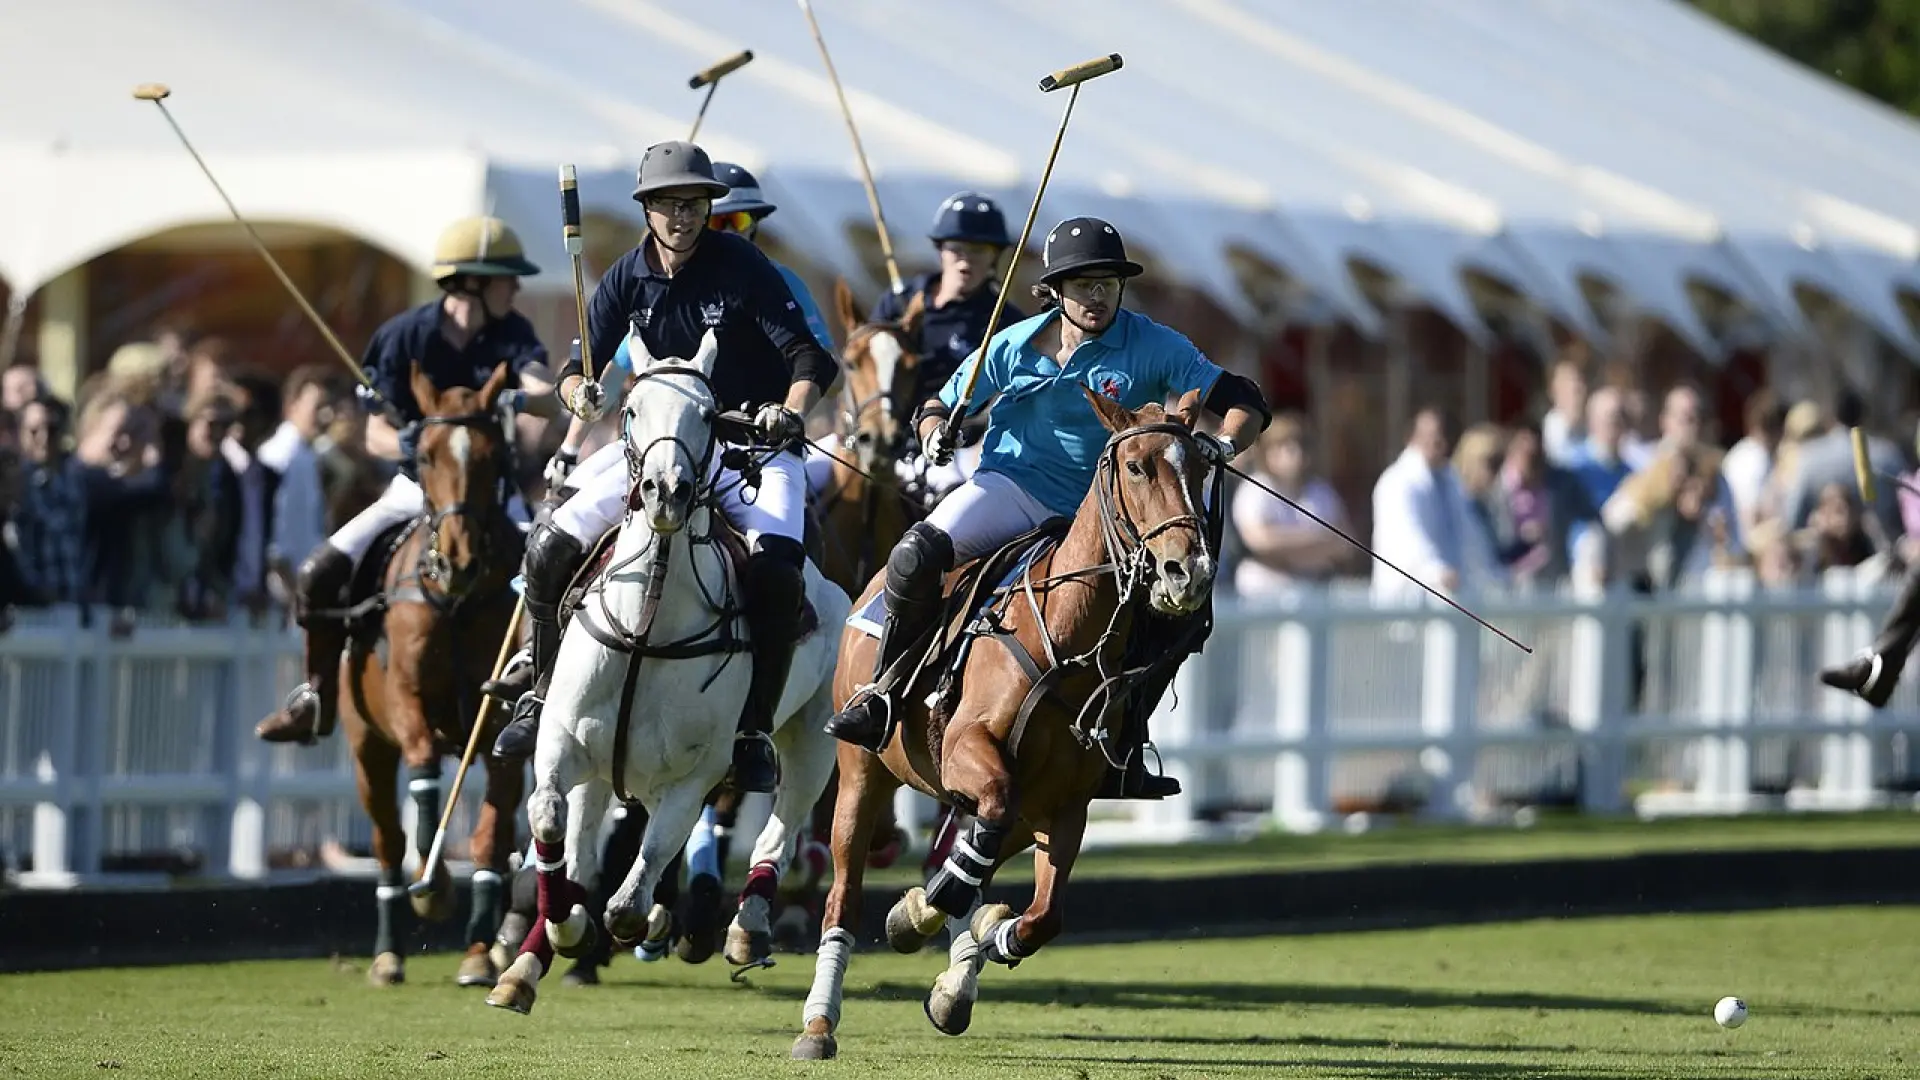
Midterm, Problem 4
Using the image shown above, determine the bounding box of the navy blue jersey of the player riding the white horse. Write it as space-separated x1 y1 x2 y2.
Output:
563 231 839 409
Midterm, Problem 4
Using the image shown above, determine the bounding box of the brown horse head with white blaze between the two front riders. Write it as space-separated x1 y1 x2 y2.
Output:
833 279 925 475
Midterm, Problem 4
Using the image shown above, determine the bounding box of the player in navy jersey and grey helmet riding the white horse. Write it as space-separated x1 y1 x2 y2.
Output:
493 142 839 792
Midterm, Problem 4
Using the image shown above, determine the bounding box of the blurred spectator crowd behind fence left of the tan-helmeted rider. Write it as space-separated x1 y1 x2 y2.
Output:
0 331 392 630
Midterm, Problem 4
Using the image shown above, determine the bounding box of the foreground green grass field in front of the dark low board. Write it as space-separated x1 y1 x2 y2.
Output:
0 909 1920 1080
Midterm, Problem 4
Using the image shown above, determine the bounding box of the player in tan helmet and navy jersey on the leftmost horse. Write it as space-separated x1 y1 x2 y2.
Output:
253 217 559 744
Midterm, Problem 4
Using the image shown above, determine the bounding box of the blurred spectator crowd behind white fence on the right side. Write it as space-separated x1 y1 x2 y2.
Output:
1231 356 1920 603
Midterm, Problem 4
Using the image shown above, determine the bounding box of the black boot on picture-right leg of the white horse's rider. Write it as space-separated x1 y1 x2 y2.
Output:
732 536 806 792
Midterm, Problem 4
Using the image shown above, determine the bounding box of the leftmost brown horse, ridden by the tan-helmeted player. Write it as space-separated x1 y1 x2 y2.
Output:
340 363 524 986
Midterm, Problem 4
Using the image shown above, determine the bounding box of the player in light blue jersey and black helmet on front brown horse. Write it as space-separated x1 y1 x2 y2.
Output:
828 217 1271 799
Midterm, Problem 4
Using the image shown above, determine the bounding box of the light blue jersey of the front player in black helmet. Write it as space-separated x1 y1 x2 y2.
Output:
941 307 1221 517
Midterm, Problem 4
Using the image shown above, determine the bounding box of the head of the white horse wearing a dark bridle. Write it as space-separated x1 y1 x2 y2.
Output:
620 329 720 536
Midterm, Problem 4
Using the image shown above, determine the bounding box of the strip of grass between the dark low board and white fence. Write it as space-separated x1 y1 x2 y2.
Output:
866 811 1920 888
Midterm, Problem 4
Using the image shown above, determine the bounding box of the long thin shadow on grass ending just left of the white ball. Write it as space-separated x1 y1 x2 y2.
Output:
862 974 1692 1015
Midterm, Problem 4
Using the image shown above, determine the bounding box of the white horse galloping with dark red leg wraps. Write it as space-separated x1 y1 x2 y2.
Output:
488 331 852 1013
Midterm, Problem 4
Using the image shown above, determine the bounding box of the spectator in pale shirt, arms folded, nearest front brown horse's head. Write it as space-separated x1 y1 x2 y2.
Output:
1233 413 1354 598
